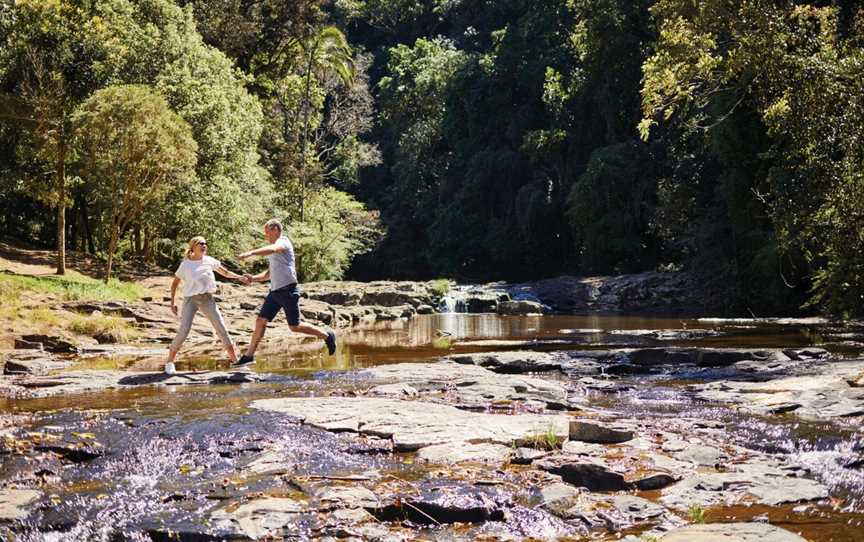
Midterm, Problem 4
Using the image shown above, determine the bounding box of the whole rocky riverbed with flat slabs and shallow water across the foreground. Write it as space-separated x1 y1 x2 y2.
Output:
0 315 864 542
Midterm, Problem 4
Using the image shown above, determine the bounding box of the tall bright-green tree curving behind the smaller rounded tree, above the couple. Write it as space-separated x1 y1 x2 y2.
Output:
92 0 272 262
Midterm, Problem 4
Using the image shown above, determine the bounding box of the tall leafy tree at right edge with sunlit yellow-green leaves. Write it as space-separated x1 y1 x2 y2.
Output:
640 0 864 315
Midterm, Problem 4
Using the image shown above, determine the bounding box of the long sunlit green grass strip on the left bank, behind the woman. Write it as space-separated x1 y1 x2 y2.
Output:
0 271 144 305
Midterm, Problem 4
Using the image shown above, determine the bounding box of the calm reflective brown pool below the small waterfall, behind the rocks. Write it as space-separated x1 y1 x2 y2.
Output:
62 313 862 373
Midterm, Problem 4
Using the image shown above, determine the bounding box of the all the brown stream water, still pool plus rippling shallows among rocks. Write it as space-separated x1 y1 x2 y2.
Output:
0 314 864 542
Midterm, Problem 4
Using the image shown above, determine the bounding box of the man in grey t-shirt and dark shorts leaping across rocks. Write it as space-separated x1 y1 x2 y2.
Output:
235 218 336 367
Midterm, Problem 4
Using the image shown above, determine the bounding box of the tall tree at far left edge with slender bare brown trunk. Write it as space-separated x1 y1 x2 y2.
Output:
0 0 101 275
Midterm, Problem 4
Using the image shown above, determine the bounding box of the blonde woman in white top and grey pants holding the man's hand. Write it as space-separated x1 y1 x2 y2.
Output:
165 236 246 375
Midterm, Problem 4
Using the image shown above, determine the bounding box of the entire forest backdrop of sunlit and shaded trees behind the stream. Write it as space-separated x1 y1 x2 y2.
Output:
0 0 864 317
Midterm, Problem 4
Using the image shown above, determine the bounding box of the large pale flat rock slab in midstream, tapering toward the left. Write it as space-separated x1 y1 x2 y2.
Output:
252 397 569 451
